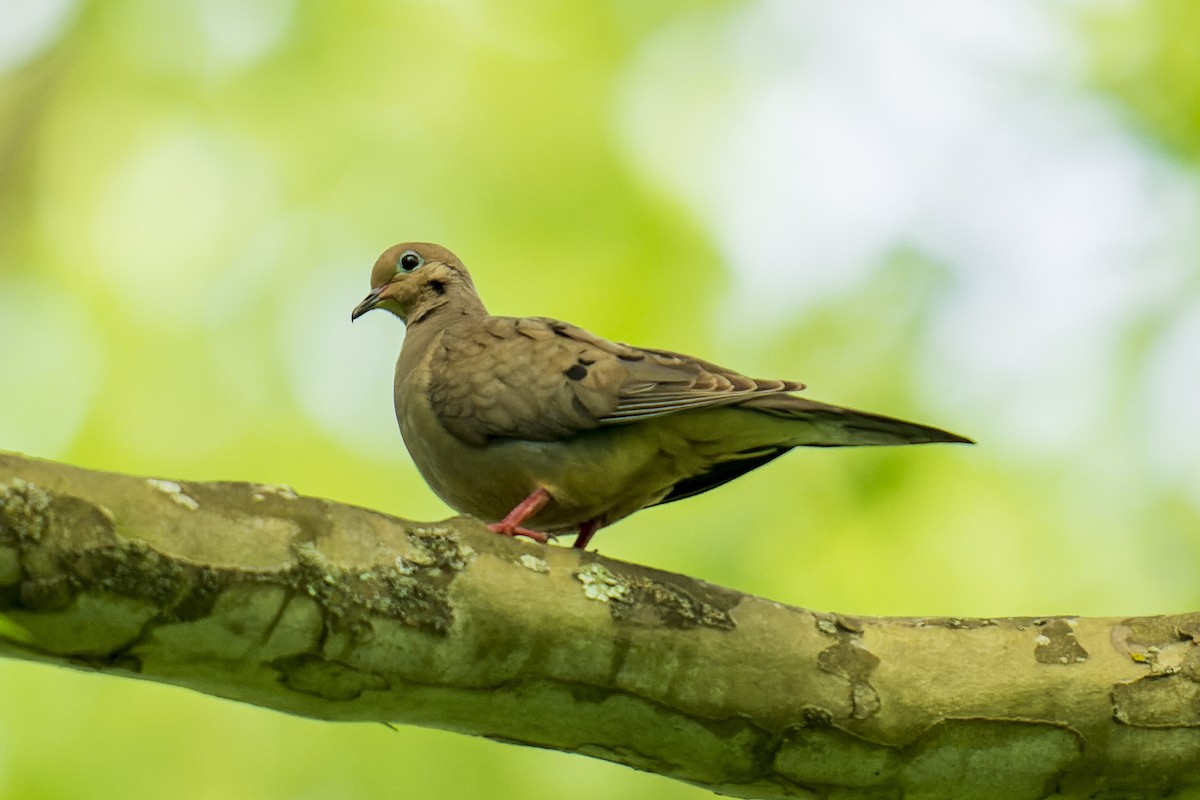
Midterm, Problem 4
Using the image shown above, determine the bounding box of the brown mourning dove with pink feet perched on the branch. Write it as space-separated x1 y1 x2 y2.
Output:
350 242 973 548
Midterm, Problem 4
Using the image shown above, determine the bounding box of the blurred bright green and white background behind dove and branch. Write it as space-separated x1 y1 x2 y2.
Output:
0 0 1200 800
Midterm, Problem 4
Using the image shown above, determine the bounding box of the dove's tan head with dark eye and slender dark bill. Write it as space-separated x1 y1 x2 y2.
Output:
350 242 486 324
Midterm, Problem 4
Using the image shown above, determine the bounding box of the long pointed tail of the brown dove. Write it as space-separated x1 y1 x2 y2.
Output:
739 395 974 447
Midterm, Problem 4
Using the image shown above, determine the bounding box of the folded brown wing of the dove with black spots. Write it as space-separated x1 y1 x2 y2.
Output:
428 317 803 444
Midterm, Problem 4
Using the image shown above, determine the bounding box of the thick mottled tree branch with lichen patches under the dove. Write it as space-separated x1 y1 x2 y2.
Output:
0 453 1200 800
